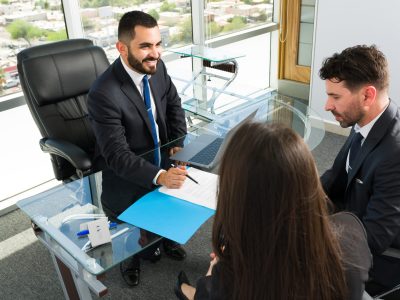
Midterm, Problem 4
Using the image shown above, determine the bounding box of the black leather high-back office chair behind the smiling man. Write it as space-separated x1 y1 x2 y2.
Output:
17 39 109 181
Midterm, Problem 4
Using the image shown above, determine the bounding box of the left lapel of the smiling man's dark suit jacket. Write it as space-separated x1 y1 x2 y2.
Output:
115 58 152 134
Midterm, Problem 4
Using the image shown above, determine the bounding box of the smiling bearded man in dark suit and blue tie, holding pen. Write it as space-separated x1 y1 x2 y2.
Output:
88 11 187 286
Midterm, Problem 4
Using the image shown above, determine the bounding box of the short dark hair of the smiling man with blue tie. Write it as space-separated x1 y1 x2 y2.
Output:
118 10 158 44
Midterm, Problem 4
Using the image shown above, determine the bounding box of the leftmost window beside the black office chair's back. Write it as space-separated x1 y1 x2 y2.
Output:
0 0 67 202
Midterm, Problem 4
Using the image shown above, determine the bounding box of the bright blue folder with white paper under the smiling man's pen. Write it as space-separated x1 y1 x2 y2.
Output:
118 168 218 244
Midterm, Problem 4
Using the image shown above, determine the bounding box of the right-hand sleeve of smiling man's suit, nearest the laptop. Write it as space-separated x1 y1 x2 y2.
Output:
162 63 186 141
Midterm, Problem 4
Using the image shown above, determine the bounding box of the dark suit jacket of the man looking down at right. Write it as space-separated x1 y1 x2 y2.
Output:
321 101 400 284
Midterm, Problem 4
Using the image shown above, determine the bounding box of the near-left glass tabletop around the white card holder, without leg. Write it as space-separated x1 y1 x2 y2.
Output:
17 177 159 275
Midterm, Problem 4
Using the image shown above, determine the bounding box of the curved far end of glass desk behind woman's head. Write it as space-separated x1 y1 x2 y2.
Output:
182 92 325 150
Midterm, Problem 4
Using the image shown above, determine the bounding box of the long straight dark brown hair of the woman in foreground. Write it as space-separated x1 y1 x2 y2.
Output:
212 123 347 300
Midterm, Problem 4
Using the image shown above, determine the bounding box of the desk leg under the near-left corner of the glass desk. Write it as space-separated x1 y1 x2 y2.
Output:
50 253 92 300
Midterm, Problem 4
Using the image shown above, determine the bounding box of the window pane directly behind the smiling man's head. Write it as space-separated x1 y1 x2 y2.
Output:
79 0 192 61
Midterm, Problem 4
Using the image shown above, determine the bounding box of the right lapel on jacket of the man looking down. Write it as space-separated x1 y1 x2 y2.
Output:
347 101 397 186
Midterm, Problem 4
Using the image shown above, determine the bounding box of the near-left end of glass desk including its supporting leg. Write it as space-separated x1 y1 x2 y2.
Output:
17 177 160 299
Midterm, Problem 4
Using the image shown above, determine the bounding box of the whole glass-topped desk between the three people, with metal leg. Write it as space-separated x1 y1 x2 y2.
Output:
17 97 324 299
